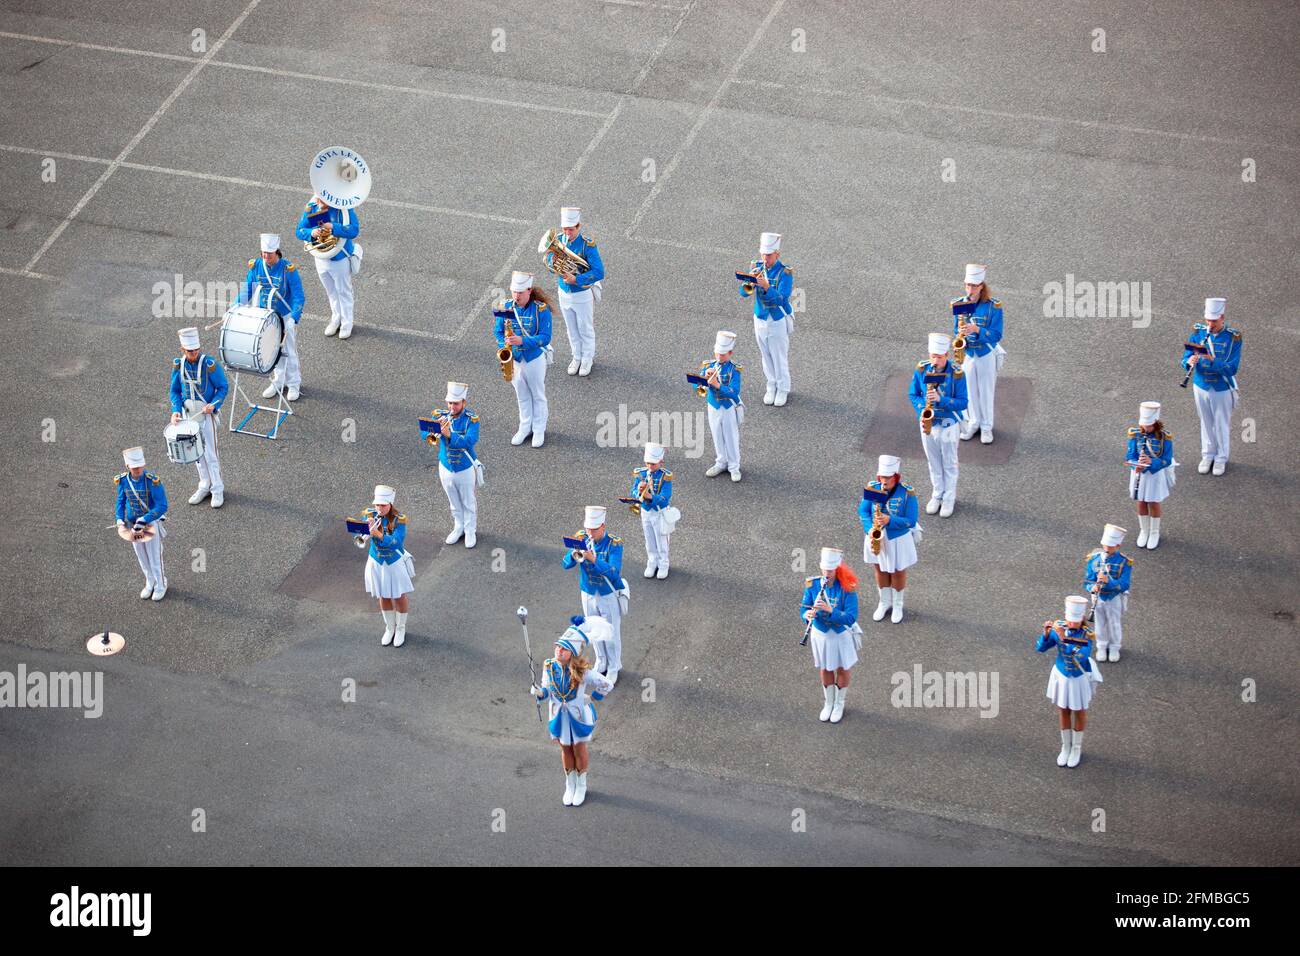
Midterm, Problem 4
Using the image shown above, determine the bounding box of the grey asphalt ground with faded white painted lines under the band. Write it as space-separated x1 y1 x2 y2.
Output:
0 0 1300 864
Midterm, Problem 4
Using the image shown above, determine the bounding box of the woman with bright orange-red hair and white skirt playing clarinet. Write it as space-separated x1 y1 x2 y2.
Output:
800 548 862 723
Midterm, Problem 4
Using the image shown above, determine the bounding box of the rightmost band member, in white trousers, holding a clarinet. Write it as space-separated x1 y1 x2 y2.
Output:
1183 299 1242 475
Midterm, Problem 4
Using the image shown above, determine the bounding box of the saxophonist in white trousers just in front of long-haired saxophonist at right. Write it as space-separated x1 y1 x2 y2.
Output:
909 332 967 518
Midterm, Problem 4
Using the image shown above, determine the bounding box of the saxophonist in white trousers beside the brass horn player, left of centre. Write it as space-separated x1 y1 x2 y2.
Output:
493 272 551 449
